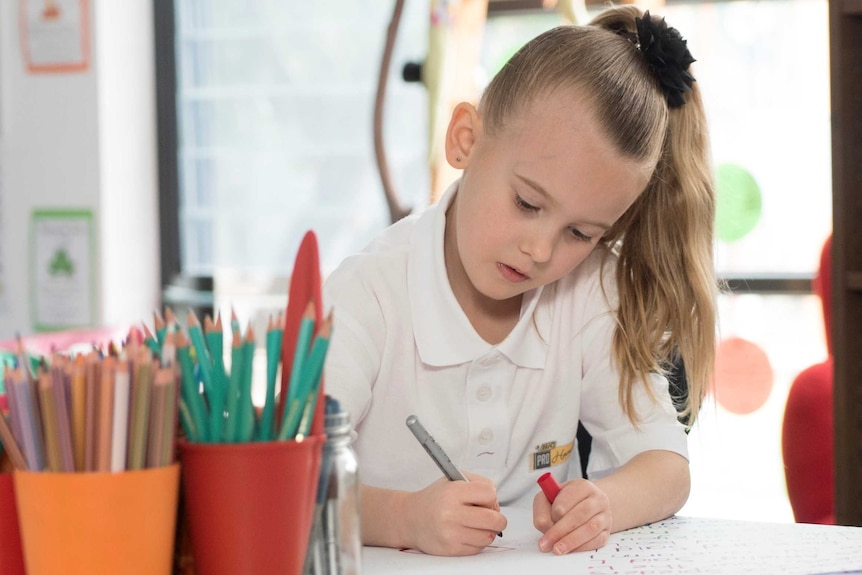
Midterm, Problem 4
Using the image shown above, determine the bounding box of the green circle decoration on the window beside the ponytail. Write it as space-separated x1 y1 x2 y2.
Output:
715 164 762 243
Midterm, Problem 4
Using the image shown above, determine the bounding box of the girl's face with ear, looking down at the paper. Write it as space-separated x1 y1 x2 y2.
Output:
446 89 649 308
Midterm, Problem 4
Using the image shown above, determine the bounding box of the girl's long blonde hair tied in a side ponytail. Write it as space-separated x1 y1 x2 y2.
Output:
480 5 718 424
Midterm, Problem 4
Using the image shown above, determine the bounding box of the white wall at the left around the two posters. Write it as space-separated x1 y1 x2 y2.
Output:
0 0 159 339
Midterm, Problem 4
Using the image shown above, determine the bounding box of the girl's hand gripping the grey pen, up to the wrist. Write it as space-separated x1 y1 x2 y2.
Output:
407 474 506 555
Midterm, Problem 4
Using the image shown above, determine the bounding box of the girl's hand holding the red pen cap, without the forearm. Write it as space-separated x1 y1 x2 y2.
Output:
533 479 612 555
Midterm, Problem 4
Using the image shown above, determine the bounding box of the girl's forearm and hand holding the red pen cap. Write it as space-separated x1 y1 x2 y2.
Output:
533 450 691 555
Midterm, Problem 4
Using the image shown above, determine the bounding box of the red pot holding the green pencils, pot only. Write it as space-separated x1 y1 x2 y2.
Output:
179 435 324 575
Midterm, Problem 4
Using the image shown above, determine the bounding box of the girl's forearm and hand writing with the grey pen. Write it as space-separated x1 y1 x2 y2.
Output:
360 475 506 555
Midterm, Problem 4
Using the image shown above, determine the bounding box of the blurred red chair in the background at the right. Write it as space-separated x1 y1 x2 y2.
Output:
781 237 835 524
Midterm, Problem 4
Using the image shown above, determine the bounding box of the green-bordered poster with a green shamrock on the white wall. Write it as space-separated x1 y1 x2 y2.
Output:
30 210 96 331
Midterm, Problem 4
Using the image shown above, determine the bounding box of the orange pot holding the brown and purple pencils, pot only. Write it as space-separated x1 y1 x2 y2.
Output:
13 463 179 575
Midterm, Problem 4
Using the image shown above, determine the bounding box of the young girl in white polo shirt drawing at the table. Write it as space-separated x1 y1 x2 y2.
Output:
324 6 716 555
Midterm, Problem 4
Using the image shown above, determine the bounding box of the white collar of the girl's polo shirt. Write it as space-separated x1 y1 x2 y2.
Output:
407 181 547 369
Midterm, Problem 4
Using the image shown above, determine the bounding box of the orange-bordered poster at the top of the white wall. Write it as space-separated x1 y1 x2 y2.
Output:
19 0 90 74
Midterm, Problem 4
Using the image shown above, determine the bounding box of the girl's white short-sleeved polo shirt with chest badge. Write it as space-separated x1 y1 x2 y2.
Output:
323 182 688 505
